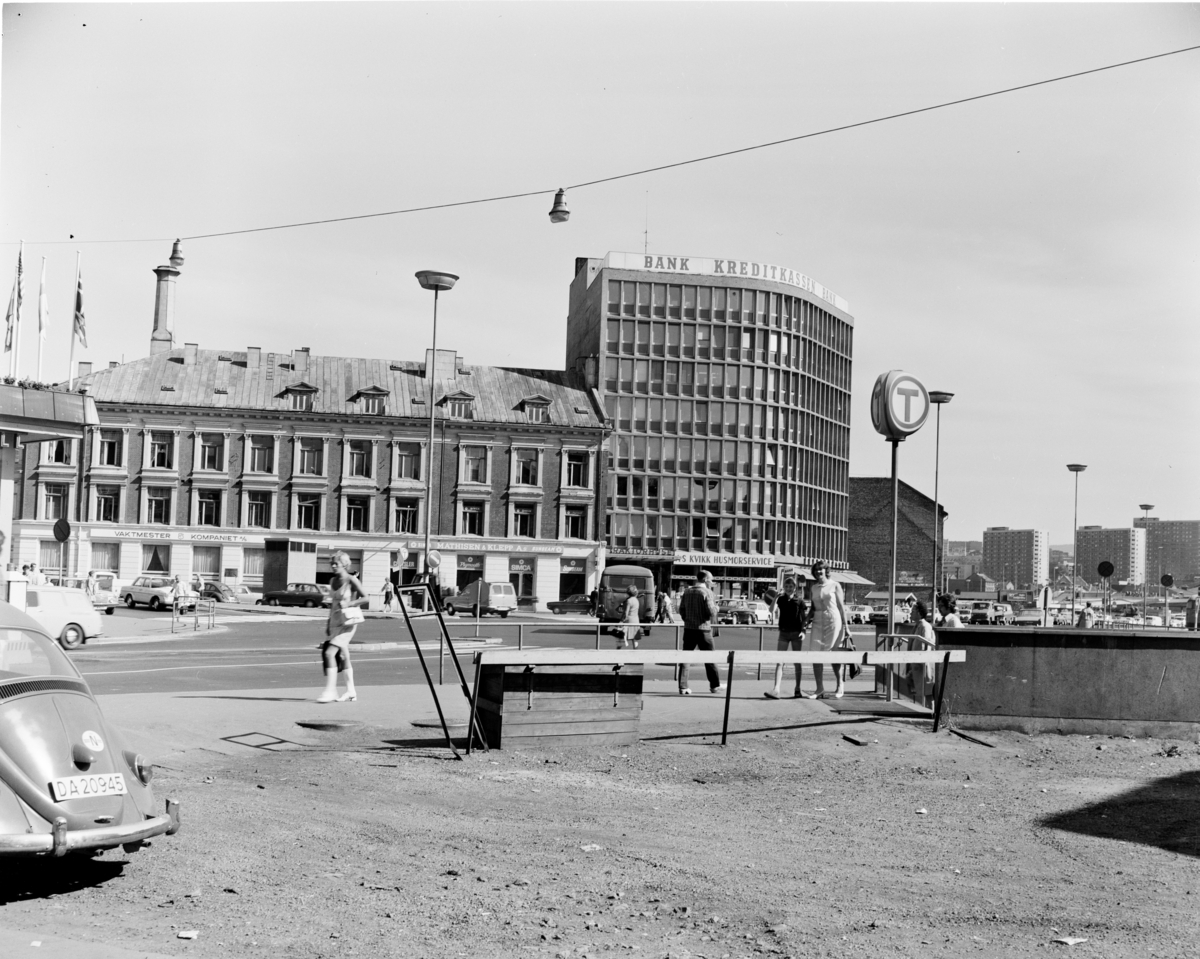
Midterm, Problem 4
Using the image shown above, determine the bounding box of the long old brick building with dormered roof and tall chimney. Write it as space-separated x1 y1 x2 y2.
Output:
14 250 604 609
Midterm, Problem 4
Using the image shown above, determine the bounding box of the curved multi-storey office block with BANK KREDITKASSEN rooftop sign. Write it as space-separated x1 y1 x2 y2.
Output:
566 253 853 595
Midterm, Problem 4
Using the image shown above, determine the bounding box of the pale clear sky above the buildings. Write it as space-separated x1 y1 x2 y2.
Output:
0 2 1200 544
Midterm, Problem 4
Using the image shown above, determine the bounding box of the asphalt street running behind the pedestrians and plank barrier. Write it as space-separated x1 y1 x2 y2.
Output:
70 607 866 695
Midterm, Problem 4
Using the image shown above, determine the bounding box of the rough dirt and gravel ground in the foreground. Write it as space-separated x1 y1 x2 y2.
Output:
0 719 1200 959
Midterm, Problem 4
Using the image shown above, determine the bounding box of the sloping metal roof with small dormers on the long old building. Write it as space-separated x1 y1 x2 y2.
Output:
76 349 602 427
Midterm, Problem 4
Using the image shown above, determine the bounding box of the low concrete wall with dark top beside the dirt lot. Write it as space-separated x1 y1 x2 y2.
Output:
937 627 1200 738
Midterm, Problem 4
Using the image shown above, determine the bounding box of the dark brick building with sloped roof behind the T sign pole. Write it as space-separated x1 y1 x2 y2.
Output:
846 476 949 600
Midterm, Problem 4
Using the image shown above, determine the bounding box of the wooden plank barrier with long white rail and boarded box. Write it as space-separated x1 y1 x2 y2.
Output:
467 649 966 754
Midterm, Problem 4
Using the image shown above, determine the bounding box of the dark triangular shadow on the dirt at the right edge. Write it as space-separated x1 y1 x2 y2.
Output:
1040 772 1200 858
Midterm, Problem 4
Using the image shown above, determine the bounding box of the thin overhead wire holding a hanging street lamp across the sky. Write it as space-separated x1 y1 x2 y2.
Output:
2 44 1200 246
